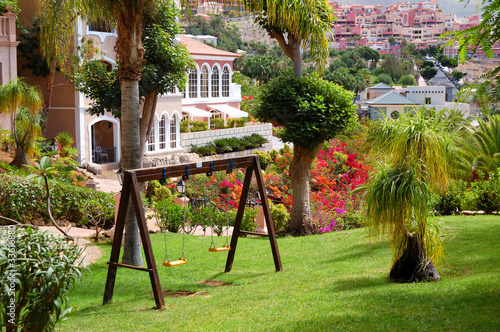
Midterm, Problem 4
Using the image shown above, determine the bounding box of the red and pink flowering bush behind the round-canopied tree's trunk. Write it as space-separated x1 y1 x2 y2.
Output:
264 140 368 233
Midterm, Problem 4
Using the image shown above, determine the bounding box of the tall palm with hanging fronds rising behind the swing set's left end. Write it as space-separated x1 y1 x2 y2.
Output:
40 0 160 266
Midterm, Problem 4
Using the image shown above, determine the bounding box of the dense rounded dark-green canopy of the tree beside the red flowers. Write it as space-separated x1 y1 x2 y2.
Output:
255 74 356 149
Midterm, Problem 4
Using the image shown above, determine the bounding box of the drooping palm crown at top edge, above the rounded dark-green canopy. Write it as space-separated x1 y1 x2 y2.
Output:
243 0 334 77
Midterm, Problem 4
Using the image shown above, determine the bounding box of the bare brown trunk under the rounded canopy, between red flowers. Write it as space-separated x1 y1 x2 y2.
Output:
289 144 323 235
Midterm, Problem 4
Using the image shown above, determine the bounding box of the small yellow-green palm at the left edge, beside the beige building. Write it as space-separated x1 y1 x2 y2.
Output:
0 78 43 167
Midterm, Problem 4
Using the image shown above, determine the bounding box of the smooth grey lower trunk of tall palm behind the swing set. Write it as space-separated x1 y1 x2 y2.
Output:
121 80 143 266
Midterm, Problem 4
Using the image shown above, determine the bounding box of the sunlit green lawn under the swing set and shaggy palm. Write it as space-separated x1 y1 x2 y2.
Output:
58 216 500 331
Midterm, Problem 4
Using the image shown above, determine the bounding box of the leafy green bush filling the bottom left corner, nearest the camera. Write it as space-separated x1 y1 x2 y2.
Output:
0 226 81 331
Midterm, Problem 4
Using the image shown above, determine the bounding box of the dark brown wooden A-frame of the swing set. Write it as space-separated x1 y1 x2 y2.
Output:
103 156 283 310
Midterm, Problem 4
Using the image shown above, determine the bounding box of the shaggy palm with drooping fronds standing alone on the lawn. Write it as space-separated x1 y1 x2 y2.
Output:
365 108 461 282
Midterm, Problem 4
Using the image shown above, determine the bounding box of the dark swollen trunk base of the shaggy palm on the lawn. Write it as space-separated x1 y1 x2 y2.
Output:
389 235 441 282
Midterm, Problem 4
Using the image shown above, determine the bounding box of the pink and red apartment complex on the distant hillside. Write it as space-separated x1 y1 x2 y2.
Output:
330 0 468 54
